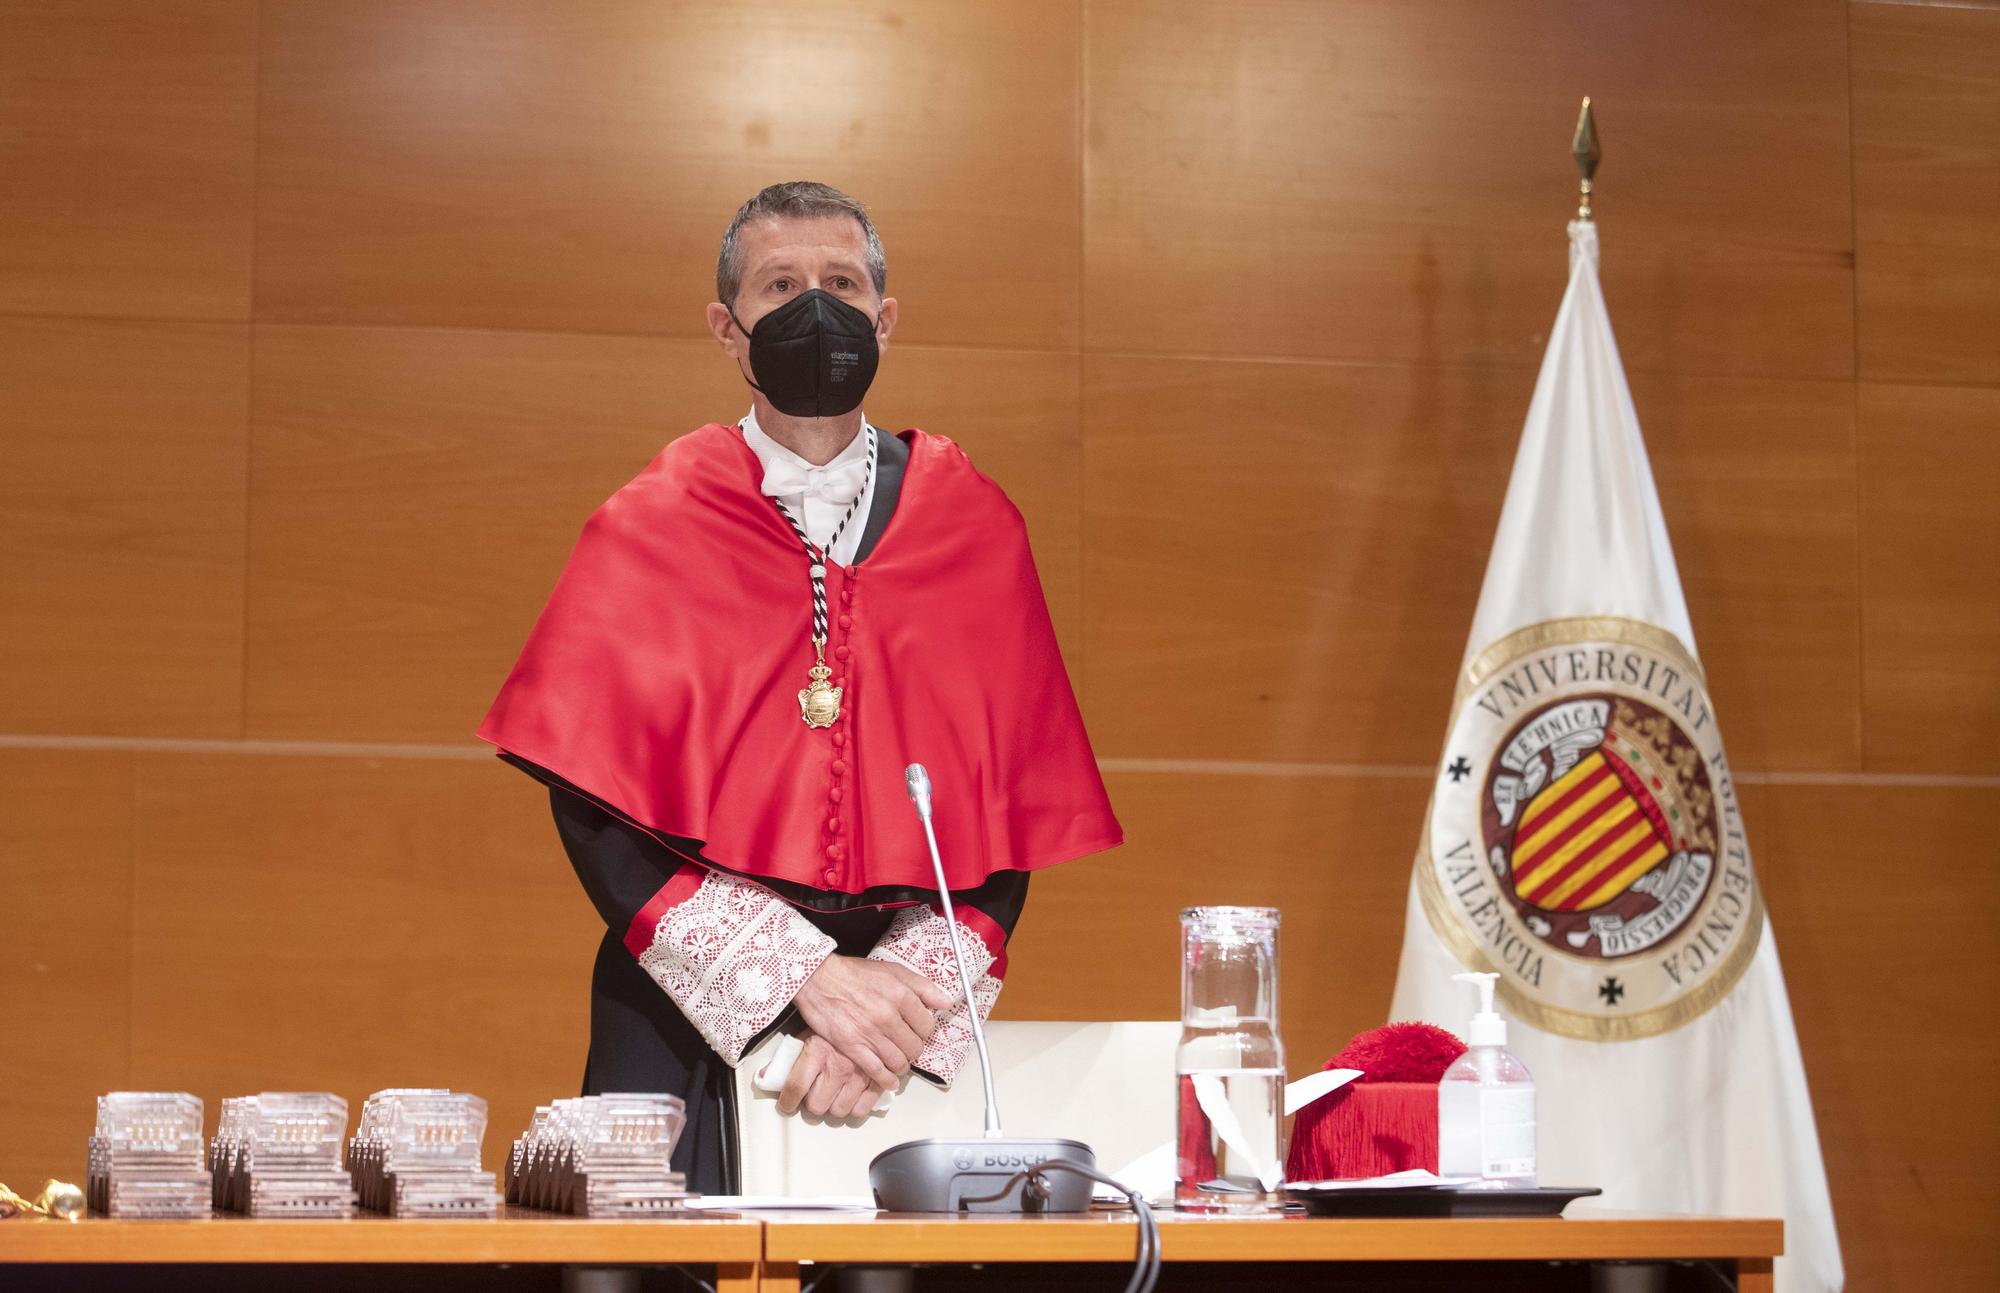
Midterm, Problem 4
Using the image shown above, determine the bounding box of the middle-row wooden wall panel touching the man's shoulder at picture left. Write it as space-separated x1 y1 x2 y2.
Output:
246 324 724 741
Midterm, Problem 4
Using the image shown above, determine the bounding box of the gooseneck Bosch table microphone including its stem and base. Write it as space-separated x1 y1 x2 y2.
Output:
868 763 1102 1213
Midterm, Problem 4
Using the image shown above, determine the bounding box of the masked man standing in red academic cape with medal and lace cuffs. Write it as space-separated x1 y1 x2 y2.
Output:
478 182 1122 1193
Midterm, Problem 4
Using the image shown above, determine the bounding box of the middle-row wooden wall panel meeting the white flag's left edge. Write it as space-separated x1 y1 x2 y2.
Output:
1084 354 1534 765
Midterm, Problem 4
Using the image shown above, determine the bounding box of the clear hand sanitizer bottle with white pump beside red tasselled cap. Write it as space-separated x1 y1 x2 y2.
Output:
1438 973 1534 1189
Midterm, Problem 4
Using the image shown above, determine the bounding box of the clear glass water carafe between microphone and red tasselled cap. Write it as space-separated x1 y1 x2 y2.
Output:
1174 907 1284 1213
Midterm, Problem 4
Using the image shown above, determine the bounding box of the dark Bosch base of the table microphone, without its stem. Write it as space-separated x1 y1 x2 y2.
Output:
868 1137 1098 1213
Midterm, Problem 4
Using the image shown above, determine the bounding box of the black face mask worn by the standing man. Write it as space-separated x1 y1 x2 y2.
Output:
730 288 882 418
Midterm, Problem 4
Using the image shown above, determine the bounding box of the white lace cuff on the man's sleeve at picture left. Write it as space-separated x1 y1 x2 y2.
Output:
626 867 834 1067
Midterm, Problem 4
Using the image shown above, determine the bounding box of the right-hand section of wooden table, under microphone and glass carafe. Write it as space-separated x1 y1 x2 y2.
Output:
760 1207 1784 1293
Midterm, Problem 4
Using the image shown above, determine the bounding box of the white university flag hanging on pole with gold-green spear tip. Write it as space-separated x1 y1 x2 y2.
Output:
1390 222 1842 1291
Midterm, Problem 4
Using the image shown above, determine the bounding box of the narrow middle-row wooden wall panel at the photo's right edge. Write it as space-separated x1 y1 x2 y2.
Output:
1860 382 2000 775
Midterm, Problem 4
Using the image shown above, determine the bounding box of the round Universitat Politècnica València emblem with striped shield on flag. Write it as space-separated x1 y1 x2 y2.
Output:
1418 618 1764 1041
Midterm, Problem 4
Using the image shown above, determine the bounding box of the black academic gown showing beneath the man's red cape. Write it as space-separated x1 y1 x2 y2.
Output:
532 436 1028 1195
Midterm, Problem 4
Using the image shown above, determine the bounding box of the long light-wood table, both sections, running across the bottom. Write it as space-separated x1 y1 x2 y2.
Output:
0 1207 1784 1293
